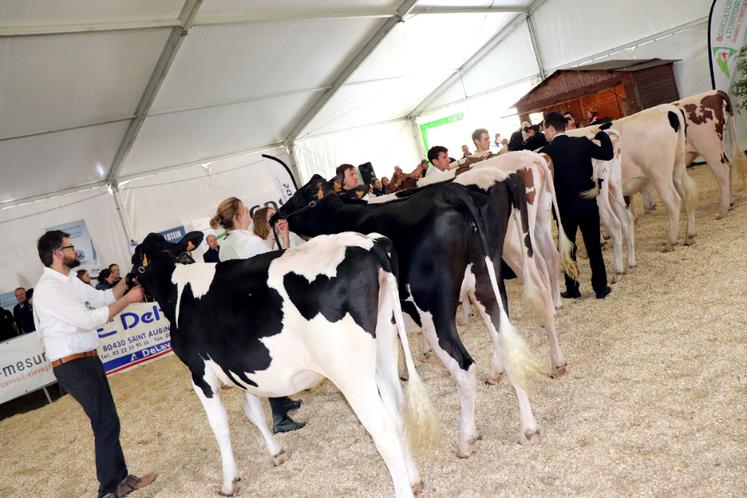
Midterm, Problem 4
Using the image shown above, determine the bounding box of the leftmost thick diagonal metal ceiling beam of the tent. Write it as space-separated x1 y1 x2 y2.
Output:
106 0 203 187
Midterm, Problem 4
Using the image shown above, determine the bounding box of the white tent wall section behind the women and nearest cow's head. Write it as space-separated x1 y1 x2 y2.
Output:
119 147 290 245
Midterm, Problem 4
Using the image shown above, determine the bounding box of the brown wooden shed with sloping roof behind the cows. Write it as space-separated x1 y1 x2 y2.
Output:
515 59 679 124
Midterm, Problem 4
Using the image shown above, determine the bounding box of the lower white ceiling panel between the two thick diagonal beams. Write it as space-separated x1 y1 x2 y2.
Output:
120 92 318 176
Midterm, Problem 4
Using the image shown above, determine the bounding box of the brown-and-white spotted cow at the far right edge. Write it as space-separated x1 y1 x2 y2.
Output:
673 90 747 218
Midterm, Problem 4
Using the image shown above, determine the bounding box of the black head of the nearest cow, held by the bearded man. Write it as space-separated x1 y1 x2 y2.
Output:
127 231 203 298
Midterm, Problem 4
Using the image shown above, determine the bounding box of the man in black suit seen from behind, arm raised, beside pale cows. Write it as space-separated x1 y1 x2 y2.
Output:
541 112 614 299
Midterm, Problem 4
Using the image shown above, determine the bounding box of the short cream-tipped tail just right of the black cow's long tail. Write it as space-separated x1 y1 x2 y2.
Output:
505 173 546 316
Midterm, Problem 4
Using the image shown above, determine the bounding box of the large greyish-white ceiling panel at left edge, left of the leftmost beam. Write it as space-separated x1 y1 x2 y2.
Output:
0 29 168 138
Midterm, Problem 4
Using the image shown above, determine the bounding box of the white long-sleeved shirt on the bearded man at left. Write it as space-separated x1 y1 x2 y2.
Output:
34 268 116 361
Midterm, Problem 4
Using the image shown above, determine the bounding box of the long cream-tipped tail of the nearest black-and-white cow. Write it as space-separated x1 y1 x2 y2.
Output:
369 234 441 451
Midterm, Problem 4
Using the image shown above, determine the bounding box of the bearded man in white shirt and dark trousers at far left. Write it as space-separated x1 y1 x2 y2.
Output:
34 230 156 498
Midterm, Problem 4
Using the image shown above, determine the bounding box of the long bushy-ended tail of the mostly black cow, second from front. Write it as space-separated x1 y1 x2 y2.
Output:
452 184 544 387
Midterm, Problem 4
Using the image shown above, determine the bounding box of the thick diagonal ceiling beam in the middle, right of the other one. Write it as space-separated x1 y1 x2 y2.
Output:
285 0 417 142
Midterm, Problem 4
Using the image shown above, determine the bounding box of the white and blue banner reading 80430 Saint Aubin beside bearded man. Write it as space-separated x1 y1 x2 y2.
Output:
96 303 171 374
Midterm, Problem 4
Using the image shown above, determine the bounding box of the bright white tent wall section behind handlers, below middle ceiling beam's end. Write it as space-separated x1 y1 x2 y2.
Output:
294 119 422 182
